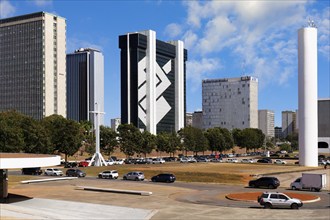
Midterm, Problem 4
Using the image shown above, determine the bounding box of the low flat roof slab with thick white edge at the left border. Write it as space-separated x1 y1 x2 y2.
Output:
0 152 61 169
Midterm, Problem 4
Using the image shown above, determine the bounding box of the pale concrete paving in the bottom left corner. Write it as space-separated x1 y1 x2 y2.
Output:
0 198 156 220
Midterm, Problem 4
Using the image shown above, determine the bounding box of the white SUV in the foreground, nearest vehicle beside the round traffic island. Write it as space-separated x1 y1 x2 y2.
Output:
258 192 303 209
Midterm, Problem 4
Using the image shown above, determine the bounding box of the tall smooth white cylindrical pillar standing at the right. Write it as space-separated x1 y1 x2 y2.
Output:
298 26 318 167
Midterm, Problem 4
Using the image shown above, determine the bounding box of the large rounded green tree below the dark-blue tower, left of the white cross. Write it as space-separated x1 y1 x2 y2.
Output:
42 115 84 161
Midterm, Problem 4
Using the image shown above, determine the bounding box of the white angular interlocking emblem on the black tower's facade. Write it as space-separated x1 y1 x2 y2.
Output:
138 57 172 126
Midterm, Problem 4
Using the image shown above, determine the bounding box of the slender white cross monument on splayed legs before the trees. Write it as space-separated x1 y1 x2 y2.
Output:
88 102 107 167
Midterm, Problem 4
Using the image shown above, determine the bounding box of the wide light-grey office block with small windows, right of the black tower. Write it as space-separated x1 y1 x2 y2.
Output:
202 76 258 130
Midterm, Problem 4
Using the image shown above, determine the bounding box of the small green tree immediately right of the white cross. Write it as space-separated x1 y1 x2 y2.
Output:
100 126 118 156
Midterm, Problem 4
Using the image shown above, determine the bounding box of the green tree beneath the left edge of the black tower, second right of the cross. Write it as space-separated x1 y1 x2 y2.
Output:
117 124 142 156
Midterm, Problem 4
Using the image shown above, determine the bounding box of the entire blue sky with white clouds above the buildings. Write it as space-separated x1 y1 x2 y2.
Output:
0 0 330 126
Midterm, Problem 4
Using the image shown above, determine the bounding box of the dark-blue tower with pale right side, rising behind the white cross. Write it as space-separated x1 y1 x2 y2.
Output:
66 48 104 125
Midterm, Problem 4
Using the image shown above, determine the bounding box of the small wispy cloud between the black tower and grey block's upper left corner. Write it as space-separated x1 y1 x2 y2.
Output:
187 58 221 90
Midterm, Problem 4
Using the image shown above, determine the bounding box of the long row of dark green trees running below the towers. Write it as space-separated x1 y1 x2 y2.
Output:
0 111 265 159
